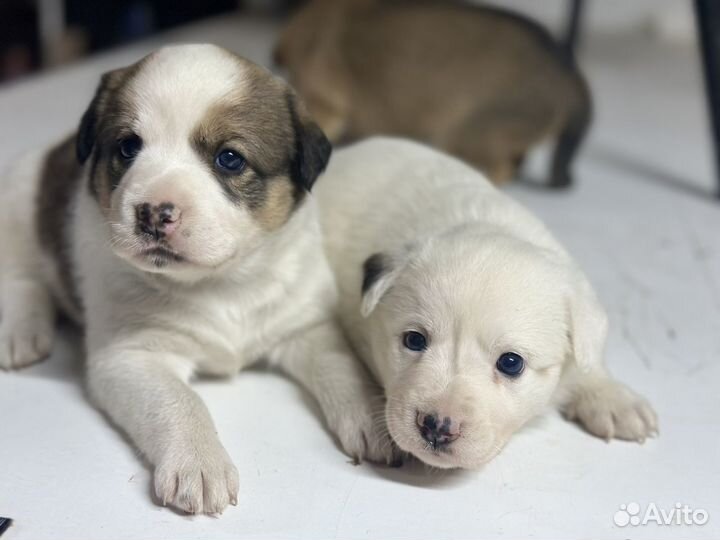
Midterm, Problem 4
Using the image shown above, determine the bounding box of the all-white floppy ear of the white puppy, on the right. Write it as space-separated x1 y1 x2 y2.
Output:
570 271 608 373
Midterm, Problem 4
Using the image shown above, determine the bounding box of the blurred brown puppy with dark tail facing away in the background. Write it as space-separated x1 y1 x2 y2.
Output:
275 0 591 186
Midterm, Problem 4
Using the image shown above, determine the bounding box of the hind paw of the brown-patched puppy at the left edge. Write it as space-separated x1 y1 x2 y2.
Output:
0 317 54 369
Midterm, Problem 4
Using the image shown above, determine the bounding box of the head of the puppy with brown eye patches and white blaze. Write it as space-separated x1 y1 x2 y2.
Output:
77 45 330 279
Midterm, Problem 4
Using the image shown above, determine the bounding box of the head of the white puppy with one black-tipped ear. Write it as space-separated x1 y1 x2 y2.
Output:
363 231 604 468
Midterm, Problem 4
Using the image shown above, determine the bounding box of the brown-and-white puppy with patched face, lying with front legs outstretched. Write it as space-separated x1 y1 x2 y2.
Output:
0 45 392 513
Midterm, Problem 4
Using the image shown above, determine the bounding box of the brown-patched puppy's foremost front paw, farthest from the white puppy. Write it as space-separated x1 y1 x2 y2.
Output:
155 443 239 514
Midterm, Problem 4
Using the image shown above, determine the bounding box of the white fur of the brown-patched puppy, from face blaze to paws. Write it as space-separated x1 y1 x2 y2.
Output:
0 46 393 513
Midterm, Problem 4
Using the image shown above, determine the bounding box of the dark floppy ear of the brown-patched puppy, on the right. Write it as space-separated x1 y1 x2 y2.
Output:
288 91 332 191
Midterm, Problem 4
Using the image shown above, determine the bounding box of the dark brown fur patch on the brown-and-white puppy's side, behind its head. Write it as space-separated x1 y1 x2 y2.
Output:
35 135 82 312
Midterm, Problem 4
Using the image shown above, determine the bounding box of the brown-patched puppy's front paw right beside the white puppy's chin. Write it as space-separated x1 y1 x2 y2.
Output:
328 399 402 467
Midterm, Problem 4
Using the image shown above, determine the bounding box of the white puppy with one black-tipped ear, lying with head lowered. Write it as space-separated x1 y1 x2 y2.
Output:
316 138 657 468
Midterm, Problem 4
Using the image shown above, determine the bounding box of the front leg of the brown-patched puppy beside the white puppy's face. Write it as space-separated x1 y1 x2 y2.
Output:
269 322 401 466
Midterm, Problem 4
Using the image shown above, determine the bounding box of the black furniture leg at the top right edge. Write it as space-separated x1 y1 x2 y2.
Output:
695 0 720 197
